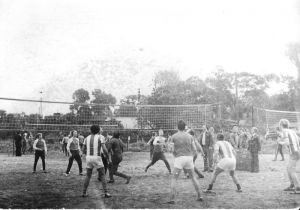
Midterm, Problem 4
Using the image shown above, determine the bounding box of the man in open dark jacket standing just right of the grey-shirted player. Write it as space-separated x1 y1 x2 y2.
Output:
199 125 214 172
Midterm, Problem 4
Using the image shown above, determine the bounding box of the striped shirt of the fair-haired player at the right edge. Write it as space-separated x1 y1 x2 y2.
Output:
282 129 300 155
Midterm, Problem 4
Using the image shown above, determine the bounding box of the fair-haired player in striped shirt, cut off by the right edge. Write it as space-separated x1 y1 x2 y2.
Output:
279 119 300 193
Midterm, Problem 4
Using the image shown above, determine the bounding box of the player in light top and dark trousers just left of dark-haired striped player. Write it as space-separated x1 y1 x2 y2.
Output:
65 130 83 176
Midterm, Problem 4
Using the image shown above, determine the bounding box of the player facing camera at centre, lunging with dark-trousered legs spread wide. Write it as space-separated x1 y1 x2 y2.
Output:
145 129 171 174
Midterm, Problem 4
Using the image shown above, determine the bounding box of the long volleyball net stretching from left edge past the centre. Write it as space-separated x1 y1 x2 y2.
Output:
0 98 220 132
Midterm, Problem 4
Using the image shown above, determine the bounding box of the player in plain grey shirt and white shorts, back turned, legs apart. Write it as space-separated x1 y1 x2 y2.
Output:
169 120 203 204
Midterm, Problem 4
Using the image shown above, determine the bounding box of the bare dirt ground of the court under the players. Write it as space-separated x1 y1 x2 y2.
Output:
0 152 300 209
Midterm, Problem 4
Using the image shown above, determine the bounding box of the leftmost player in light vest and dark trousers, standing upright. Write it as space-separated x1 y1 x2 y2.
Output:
32 133 47 173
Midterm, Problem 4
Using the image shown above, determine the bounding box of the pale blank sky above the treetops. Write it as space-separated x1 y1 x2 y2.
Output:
0 0 300 114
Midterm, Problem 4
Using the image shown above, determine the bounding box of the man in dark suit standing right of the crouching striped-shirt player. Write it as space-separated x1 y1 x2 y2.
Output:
248 127 261 172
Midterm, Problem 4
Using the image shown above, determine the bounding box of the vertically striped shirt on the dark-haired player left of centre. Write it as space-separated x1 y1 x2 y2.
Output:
83 134 105 156
